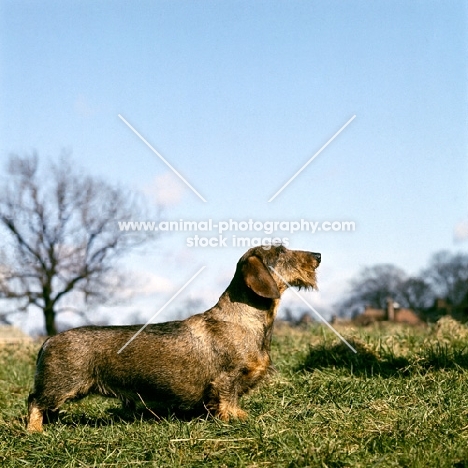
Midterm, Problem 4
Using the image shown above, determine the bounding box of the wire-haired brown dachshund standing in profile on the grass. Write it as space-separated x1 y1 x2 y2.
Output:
27 245 321 431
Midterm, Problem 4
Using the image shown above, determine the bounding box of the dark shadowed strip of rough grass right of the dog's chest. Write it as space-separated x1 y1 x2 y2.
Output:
296 341 468 377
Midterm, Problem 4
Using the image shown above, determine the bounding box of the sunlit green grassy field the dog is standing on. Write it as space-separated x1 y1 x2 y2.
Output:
0 319 468 467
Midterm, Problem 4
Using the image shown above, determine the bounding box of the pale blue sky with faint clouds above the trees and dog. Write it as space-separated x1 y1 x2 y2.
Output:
0 0 468 330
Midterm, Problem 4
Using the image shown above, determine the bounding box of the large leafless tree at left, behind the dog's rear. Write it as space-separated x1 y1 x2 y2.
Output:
0 154 154 335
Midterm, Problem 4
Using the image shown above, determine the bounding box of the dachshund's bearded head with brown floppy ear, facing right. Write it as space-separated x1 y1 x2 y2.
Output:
237 245 321 299
